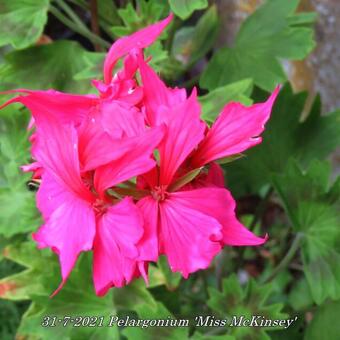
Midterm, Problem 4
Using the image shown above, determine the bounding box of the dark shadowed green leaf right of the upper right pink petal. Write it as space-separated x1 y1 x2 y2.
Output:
226 84 340 196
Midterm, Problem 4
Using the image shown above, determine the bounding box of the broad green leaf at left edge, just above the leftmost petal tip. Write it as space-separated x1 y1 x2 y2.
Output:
0 41 90 93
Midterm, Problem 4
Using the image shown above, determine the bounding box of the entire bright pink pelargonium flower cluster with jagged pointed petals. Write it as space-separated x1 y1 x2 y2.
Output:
3 15 279 295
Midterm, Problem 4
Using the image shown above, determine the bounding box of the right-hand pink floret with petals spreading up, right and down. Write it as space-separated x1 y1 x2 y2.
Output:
137 61 278 277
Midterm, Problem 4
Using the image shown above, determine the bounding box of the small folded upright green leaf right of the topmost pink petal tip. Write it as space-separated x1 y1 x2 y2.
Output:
171 6 218 67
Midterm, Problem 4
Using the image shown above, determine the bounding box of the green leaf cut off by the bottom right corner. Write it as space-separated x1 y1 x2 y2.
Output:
304 301 340 340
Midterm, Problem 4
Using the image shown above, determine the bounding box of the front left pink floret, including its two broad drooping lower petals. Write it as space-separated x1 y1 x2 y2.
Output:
33 111 163 295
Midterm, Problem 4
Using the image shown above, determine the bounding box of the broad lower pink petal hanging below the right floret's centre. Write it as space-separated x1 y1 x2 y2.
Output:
159 194 222 278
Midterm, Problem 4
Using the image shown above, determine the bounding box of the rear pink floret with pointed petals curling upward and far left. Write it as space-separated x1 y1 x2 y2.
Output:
0 14 173 170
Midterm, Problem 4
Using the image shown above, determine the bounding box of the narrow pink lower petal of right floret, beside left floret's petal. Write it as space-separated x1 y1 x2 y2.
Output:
137 196 159 261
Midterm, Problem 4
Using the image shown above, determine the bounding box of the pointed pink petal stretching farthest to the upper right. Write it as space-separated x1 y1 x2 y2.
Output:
192 87 280 167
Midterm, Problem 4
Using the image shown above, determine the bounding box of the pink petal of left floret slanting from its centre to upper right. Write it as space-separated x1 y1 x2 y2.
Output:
94 127 164 194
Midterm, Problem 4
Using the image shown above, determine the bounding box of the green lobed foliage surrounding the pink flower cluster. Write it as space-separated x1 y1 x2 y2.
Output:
0 0 340 340
